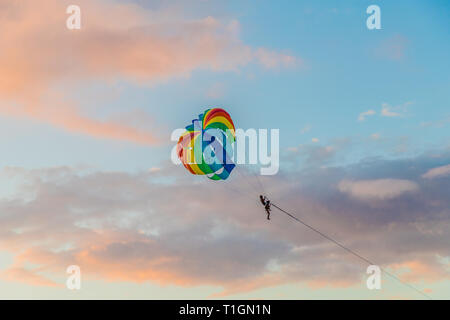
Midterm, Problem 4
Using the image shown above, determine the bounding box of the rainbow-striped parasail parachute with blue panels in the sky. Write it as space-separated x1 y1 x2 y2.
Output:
177 108 236 180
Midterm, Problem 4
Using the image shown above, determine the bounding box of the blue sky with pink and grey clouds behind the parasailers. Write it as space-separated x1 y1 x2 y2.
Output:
0 0 450 299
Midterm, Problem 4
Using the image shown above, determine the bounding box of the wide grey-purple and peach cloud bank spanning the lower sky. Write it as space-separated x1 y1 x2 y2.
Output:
0 150 450 297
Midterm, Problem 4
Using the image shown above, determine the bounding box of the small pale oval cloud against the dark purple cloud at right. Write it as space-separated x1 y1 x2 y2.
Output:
338 179 419 200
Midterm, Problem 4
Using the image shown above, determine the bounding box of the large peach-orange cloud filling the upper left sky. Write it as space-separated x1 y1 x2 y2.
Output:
0 0 298 145
